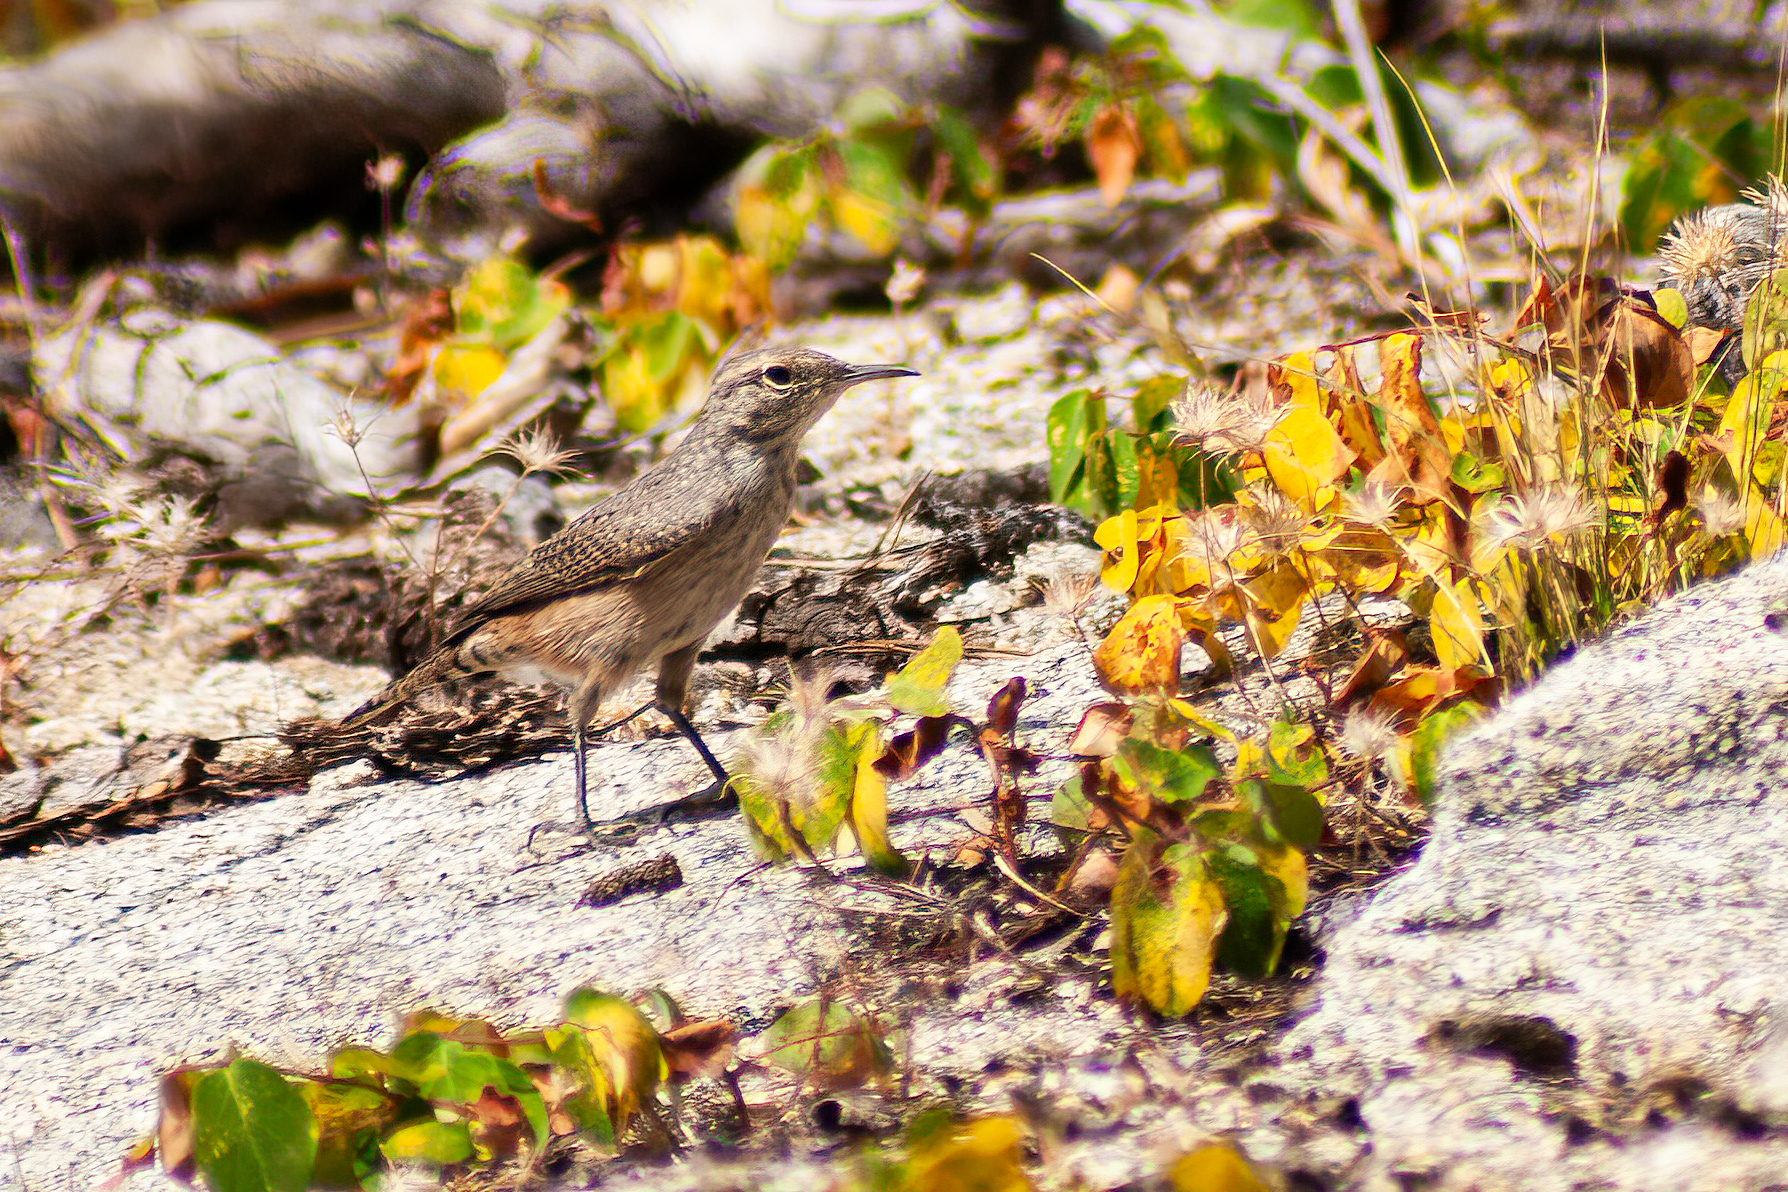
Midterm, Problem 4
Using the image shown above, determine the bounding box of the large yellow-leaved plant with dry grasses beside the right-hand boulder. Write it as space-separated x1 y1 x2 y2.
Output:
1051 253 1788 1015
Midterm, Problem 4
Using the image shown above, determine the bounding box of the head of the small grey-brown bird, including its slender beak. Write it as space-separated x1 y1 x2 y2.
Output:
701 347 919 443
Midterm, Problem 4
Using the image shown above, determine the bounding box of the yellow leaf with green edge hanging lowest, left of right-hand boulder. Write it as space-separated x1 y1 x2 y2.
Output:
1110 839 1228 1019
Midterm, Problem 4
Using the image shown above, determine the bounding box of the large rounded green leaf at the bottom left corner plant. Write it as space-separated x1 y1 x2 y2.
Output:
193 1060 316 1192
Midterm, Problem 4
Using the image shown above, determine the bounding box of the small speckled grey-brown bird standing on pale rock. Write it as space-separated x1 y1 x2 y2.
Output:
343 348 919 827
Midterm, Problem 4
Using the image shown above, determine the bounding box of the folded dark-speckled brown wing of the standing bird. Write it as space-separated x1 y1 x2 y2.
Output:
447 477 728 642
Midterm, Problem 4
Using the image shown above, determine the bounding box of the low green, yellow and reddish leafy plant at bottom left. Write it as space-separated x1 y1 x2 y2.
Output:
127 988 733 1192
